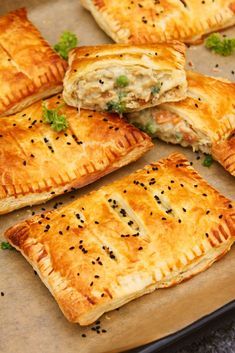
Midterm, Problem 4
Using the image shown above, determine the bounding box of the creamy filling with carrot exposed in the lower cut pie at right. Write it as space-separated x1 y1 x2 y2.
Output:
128 108 211 153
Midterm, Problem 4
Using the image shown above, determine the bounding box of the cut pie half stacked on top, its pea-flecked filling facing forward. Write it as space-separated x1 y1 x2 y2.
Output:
63 42 187 114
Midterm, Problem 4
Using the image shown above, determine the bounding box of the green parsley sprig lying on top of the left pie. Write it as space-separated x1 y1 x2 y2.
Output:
42 102 69 132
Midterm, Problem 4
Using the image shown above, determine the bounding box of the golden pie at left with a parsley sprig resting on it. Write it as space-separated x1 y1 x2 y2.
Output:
0 96 152 214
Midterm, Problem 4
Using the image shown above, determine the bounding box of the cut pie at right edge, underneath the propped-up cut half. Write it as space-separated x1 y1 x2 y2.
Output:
128 72 235 175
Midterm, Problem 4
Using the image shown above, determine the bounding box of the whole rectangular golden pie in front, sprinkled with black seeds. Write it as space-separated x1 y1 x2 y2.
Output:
5 154 235 325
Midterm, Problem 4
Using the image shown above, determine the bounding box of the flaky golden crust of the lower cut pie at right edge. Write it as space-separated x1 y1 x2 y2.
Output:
129 71 235 175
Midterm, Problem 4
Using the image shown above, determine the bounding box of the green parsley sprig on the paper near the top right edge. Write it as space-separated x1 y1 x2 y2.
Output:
205 33 235 56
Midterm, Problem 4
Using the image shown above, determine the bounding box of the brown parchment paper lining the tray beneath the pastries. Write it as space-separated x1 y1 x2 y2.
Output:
0 0 235 353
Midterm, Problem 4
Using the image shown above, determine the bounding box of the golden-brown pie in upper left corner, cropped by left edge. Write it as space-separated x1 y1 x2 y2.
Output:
0 8 67 116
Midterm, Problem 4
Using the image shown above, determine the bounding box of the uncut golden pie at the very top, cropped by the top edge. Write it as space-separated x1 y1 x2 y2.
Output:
81 0 235 44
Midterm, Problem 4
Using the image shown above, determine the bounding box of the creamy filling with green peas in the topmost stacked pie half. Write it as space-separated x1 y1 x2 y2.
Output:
74 66 175 114
